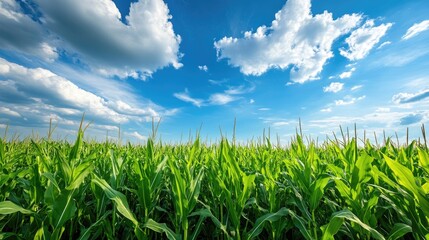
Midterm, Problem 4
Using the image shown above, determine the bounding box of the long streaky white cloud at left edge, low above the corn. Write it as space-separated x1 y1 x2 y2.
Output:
0 58 166 124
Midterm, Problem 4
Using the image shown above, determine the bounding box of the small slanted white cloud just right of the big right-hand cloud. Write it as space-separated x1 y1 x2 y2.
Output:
340 20 392 61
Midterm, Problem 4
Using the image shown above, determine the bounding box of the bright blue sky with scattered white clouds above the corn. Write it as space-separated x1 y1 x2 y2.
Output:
0 0 429 142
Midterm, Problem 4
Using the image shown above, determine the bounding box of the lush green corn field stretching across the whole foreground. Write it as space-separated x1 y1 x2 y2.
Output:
0 124 429 240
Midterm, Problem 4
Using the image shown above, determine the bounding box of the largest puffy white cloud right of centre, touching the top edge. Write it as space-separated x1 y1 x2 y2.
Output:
214 0 361 83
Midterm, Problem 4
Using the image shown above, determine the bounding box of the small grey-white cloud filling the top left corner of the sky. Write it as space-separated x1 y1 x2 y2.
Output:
0 0 58 62
